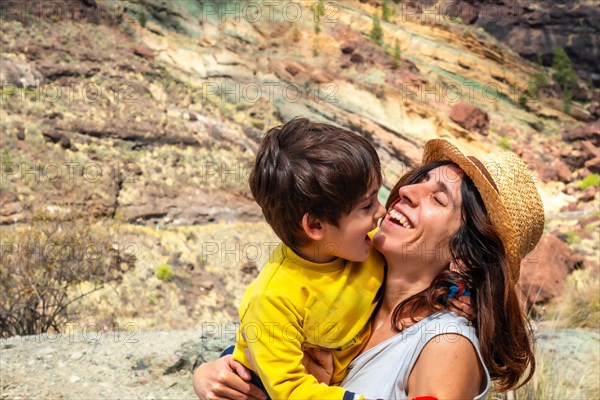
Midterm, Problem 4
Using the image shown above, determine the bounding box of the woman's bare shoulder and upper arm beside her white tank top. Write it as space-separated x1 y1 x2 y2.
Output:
407 334 484 400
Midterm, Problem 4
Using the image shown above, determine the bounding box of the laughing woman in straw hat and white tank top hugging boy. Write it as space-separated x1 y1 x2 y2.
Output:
194 139 544 399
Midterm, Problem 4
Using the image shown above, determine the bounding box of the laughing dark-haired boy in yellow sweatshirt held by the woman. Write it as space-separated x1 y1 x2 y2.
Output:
233 118 385 399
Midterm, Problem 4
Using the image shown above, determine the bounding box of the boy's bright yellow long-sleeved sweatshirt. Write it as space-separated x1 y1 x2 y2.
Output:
233 244 384 399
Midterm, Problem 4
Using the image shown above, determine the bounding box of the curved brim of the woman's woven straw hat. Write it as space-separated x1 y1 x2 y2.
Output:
423 139 521 283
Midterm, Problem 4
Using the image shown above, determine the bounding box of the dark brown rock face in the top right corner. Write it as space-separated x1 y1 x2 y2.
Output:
436 0 600 81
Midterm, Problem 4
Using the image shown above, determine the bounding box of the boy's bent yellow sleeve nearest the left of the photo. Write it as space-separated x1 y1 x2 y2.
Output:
236 293 354 400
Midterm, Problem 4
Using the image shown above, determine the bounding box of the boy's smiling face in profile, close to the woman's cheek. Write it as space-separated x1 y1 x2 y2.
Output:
321 182 385 262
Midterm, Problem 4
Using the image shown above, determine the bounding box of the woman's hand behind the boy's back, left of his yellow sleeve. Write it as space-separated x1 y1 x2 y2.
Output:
193 355 267 400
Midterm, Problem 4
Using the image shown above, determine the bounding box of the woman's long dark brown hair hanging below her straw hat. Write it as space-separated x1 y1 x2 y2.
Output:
386 161 535 391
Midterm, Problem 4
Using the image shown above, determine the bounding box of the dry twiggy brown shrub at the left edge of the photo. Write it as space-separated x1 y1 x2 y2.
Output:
0 215 136 338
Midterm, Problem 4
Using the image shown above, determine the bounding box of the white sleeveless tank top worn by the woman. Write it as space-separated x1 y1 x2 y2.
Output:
341 311 491 400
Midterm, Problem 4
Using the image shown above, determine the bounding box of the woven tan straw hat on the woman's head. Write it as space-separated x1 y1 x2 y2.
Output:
423 139 544 284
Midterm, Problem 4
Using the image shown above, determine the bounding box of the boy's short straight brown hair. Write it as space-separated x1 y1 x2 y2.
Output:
249 118 382 249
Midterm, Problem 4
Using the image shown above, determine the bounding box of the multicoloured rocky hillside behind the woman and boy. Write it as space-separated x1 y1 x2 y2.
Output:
0 0 600 397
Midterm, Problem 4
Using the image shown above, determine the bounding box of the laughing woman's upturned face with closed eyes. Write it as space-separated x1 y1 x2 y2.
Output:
374 165 463 267
